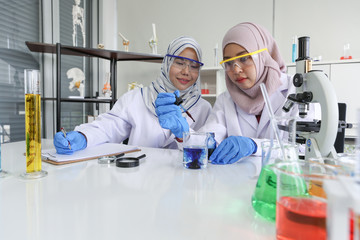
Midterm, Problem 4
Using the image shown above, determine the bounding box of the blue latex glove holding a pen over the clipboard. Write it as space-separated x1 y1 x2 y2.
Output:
54 131 87 155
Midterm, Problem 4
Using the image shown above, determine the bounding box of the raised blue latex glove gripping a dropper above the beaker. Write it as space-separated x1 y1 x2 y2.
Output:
155 90 189 138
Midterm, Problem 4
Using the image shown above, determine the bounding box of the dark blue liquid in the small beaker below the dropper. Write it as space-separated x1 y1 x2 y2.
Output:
183 146 207 169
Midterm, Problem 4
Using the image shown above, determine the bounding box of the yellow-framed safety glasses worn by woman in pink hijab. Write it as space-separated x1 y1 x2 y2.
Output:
220 48 268 72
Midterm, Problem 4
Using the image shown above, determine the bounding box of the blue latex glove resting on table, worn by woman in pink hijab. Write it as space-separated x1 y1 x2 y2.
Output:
210 136 257 164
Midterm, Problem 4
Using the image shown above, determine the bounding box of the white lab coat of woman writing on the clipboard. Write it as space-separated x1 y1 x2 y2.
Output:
75 89 211 148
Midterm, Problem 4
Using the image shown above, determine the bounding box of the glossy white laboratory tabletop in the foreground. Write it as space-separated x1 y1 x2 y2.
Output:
0 139 275 240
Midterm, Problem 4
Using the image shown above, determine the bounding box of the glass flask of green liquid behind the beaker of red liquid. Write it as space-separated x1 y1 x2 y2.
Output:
251 140 299 221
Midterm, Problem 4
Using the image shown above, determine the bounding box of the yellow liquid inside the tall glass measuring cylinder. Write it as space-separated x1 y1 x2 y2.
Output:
25 94 41 173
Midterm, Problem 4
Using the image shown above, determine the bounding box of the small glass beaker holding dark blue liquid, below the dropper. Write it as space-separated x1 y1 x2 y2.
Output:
183 132 210 169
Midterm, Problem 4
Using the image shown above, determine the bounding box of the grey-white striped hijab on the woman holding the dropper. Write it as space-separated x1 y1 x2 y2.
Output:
141 36 202 116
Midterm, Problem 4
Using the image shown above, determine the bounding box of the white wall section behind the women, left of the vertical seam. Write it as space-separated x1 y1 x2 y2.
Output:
118 0 273 96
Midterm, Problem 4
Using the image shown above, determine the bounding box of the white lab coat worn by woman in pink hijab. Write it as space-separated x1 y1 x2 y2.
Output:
199 74 314 155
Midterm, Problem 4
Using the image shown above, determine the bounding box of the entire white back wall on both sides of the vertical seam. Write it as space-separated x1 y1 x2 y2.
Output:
117 0 360 96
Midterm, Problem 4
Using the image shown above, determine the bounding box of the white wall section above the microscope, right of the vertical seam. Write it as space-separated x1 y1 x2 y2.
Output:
274 0 360 62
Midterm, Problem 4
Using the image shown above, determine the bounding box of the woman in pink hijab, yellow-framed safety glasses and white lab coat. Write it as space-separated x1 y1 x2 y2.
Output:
200 22 314 164
